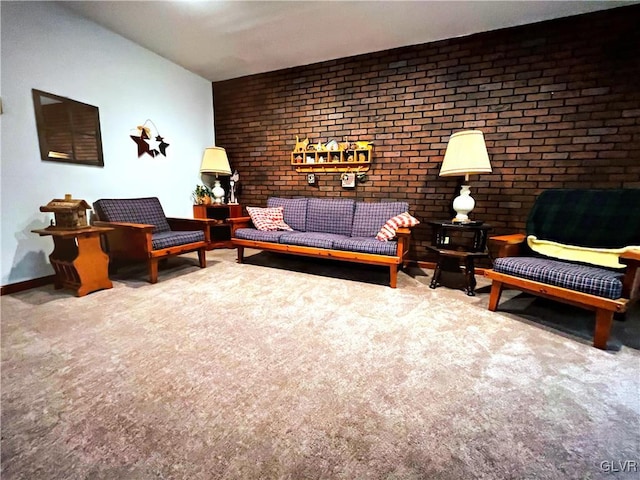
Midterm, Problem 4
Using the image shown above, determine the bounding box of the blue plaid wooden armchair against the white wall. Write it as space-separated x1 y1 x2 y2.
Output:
93 197 209 283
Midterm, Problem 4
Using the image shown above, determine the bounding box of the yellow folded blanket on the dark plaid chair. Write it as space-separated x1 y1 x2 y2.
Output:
527 235 640 268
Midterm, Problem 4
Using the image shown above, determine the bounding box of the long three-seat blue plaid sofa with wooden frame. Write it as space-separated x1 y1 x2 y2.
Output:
229 197 417 288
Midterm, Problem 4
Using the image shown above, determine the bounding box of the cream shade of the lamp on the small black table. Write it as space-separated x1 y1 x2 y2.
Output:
440 130 491 180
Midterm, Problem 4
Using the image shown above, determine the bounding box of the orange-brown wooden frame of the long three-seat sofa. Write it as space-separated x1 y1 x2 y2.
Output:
228 217 411 288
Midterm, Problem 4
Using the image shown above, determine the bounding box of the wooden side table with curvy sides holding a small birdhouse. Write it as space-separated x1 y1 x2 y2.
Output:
31 227 113 297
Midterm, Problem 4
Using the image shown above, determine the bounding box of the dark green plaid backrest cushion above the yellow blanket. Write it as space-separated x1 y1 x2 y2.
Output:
526 188 640 248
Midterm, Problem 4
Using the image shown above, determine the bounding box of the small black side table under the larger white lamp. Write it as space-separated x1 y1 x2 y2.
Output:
427 221 491 297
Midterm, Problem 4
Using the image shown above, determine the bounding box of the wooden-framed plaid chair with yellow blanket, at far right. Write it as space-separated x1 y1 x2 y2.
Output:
485 189 640 349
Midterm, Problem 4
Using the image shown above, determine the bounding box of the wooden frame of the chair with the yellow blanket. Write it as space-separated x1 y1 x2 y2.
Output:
484 234 640 350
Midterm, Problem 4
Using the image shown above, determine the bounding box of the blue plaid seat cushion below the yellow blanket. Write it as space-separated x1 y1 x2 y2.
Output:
493 257 623 299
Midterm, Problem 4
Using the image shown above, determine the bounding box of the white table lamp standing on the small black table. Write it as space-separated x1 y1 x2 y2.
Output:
440 130 491 223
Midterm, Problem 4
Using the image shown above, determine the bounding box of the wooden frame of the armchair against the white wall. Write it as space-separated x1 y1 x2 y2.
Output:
92 217 216 283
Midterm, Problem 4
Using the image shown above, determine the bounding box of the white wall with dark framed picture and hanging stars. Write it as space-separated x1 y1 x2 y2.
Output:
0 1 214 285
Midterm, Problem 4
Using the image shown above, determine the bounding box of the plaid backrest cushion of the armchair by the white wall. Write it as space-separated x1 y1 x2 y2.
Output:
93 197 171 233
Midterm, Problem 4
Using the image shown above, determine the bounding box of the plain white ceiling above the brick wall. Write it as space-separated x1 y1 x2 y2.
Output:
59 0 640 82
